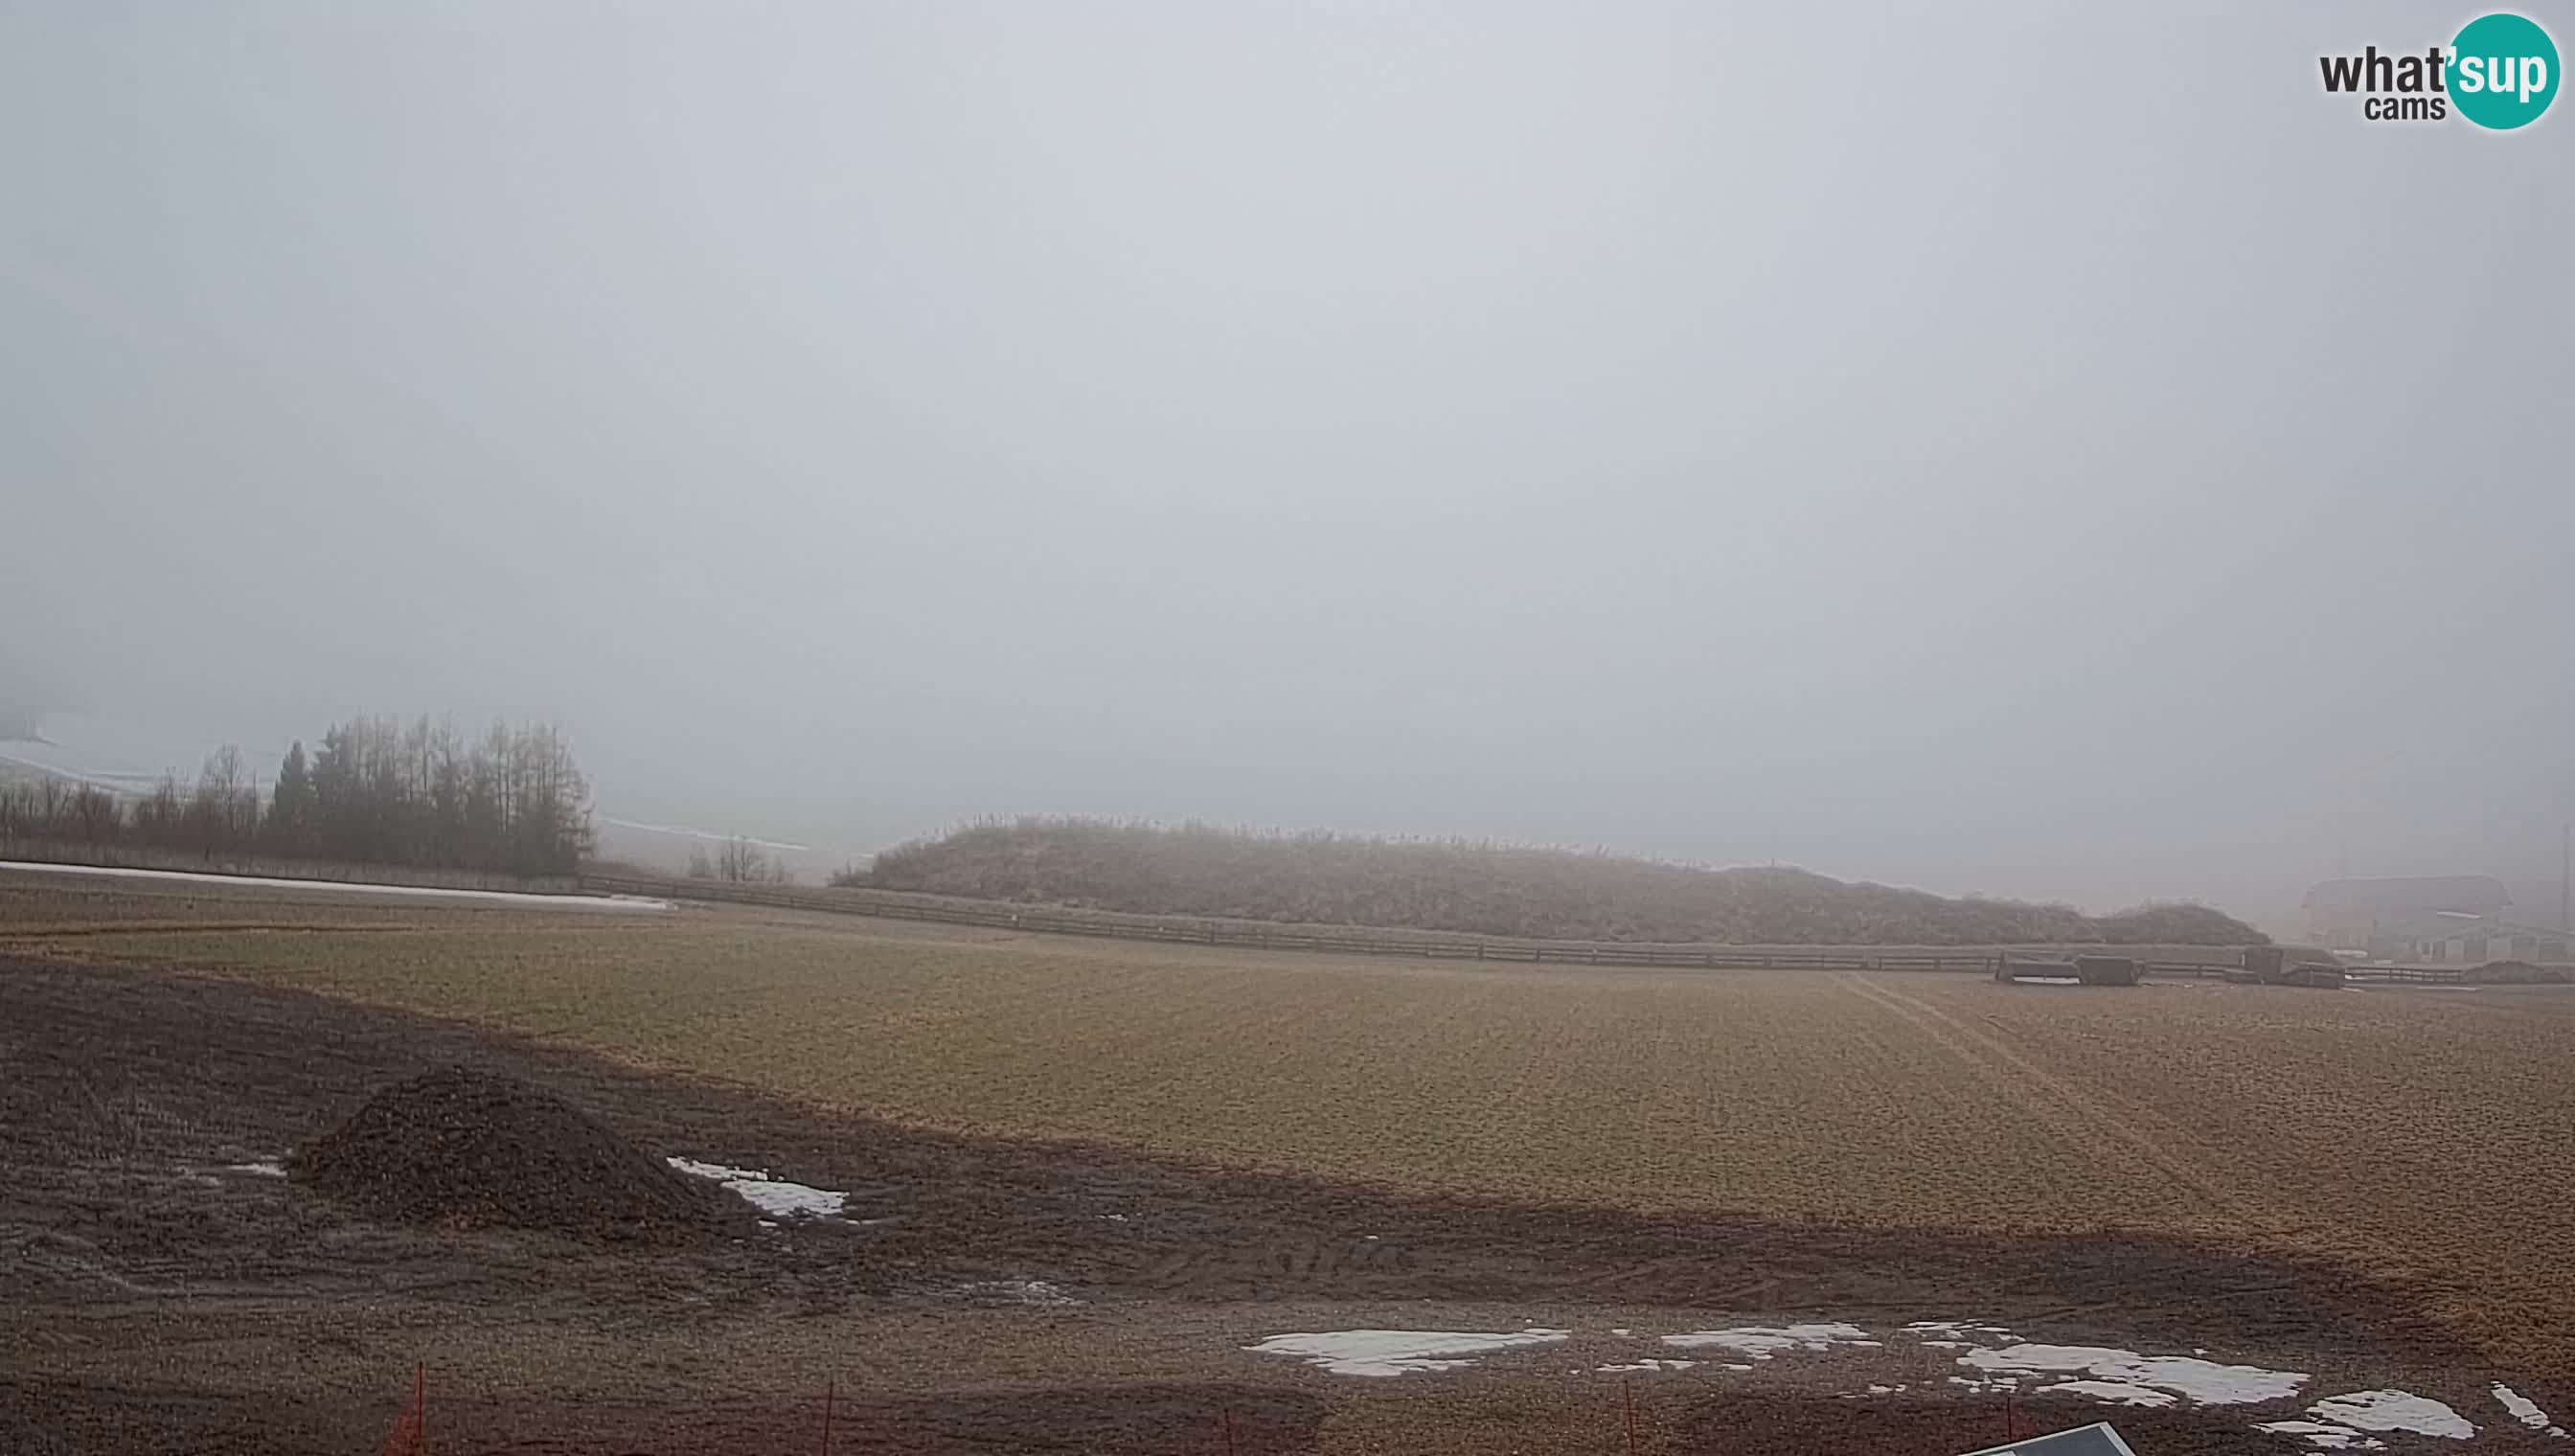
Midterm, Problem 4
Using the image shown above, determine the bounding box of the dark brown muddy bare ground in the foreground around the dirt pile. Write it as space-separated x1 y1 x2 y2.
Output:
0 961 2575 1456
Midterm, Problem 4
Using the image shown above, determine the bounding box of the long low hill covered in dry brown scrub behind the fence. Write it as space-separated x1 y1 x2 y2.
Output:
839 820 2266 945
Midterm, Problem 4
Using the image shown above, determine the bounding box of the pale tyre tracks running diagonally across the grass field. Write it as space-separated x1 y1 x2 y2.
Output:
1836 971 2305 1242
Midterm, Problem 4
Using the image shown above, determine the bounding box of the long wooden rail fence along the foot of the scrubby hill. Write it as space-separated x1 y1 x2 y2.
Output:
581 874 2243 977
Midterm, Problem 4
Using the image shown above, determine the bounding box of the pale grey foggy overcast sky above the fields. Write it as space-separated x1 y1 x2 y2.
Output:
0 0 2575 920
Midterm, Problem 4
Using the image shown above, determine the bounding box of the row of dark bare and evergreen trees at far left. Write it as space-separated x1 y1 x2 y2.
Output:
0 717 592 876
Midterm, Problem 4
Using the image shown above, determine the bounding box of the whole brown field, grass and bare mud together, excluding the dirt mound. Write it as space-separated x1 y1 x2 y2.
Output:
0 860 2575 1451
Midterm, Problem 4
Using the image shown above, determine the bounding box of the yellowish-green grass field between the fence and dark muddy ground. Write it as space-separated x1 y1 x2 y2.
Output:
14 881 2575 1360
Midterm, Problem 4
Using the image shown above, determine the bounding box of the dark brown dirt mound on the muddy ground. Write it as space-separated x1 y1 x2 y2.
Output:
288 1067 749 1244
